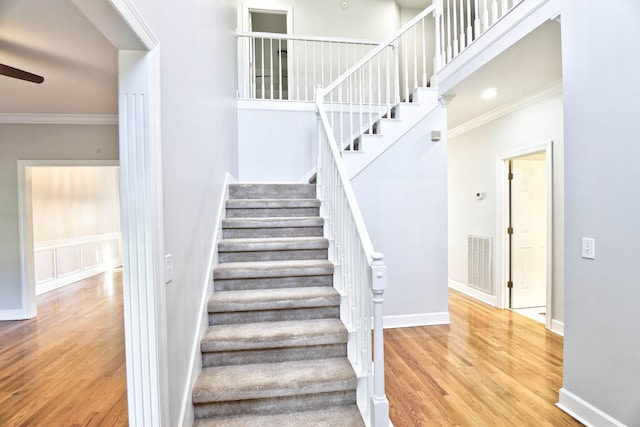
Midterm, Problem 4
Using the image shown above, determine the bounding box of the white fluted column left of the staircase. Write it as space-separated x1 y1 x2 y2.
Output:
118 48 169 427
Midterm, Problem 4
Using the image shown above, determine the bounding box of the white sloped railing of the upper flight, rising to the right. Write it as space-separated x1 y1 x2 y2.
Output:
321 5 442 150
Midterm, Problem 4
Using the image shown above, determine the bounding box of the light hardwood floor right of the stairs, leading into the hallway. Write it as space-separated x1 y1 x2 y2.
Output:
385 291 582 427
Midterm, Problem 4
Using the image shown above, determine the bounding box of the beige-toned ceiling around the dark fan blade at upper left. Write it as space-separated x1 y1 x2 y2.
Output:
0 0 118 114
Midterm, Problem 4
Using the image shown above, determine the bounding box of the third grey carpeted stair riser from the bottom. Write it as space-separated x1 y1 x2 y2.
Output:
209 306 340 325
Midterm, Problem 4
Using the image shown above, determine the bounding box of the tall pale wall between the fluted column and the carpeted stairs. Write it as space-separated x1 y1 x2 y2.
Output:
133 0 237 426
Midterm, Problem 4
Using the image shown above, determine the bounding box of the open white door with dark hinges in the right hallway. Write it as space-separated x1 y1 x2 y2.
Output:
511 153 547 308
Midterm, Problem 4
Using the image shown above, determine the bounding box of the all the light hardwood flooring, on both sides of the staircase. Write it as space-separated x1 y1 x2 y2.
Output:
0 271 581 427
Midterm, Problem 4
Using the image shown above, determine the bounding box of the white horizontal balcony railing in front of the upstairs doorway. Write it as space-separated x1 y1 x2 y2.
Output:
237 32 379 101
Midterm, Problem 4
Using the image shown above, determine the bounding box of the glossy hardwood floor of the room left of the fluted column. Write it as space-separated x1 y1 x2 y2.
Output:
0 270 128 427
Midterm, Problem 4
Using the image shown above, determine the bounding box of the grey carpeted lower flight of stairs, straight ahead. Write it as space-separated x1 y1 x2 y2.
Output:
193 184 364 427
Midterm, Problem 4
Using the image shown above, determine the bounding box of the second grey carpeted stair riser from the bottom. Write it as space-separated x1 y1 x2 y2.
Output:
202 343 347 368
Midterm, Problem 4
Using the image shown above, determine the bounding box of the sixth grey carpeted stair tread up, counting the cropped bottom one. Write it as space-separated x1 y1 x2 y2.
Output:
218 236 329 252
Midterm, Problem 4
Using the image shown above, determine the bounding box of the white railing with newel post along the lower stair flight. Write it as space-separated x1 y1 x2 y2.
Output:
316 88 389 427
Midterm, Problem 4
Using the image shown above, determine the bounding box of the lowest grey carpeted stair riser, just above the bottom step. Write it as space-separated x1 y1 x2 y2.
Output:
194 388 356 420
